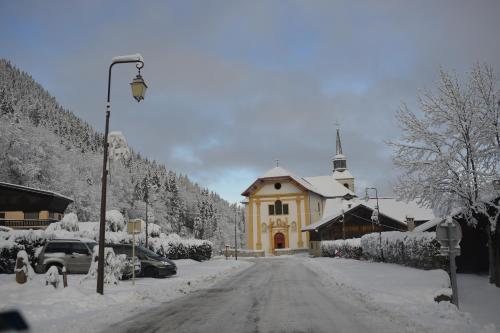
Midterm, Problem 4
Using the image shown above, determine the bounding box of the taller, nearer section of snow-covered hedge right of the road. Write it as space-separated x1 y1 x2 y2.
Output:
361 231 446 269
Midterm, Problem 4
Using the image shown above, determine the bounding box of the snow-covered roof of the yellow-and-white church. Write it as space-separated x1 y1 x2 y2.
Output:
242 166 355 198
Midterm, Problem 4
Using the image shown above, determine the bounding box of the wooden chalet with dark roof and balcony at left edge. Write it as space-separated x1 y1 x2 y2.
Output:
0 182 73 229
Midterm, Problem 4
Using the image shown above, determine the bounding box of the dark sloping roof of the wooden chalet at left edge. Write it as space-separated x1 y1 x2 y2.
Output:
0 182 73 213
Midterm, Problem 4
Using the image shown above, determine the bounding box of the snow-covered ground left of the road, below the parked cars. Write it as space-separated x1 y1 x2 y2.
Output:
0 259 252 332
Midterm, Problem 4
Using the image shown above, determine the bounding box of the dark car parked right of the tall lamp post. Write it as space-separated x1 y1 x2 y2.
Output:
106 244 177 278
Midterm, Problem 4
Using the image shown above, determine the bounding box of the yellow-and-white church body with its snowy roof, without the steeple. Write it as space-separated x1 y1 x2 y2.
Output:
243 166 354 255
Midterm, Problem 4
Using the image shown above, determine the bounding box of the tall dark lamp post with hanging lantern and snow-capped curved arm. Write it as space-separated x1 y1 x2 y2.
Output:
97 53 148 295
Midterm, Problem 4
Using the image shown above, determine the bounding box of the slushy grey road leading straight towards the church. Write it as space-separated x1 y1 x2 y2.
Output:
104 257 406 333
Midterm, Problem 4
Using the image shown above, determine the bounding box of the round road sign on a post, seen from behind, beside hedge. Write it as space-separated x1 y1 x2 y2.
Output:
436 217 462 308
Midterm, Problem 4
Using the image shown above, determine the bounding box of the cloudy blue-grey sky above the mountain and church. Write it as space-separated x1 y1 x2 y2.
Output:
0 0 500 202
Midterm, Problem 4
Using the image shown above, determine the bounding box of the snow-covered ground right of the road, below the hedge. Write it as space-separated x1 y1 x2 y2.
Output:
306 258 500 333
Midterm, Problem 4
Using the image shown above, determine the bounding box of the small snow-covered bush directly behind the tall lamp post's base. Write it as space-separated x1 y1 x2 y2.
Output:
83 245 128 284
